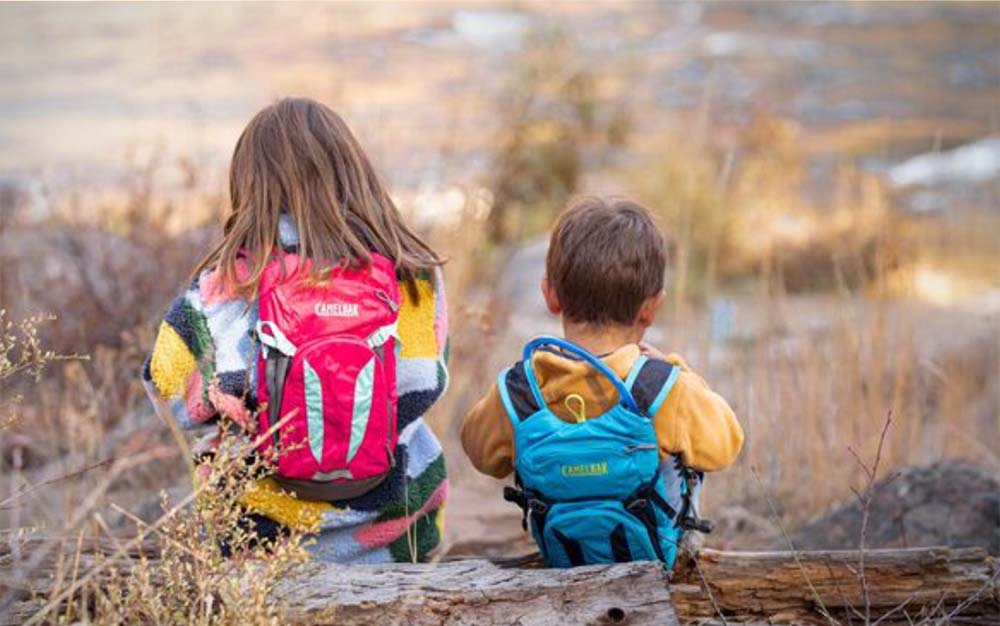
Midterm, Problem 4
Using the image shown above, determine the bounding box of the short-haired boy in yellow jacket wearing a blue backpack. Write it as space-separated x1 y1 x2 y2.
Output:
462 197 743 567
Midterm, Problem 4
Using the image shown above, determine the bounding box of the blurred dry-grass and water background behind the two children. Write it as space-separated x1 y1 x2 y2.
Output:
0 1 1000 554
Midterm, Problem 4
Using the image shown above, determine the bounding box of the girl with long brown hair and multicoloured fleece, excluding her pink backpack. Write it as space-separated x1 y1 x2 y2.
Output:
143 98 448 563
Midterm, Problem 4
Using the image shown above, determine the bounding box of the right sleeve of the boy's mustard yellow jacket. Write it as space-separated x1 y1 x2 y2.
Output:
653 355 743 472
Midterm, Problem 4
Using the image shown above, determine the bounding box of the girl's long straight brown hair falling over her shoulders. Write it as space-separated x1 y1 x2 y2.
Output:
195 98 442 296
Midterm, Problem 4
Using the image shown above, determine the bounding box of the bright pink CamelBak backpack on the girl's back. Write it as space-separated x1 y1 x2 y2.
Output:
257 254 400 501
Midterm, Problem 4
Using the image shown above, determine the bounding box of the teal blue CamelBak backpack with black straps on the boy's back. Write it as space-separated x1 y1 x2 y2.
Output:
497 337 711 568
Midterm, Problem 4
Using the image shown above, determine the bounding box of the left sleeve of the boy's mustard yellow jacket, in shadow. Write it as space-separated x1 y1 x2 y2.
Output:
462 383 514 478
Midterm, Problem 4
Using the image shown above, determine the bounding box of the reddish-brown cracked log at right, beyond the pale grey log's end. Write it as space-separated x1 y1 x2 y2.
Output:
670 548 1000 625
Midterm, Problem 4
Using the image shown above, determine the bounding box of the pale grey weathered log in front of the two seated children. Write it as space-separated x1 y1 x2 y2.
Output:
273 560 678 626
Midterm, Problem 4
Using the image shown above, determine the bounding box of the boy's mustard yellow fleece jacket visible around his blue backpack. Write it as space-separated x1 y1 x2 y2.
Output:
462 344 743 478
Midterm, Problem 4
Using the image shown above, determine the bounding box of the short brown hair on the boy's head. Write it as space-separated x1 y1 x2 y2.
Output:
545 196 667 326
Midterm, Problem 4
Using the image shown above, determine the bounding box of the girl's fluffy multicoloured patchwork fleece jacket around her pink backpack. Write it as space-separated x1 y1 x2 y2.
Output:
143 216 448 563
